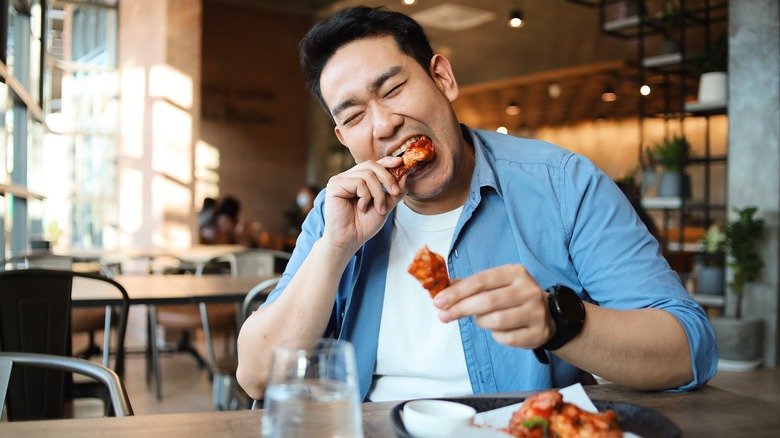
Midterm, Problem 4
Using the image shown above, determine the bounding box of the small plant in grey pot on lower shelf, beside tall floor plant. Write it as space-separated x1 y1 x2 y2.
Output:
695 223 726 295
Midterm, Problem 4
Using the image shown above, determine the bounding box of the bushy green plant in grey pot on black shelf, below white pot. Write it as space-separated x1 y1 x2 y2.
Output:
653 134 694 198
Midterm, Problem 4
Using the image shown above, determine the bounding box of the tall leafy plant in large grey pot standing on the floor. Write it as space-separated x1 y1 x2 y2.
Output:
712 207 764 371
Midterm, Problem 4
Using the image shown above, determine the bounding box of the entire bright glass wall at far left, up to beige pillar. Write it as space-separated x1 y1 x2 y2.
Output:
0 0 119 258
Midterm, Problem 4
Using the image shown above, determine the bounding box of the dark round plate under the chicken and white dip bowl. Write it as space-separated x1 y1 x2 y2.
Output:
390 397 680 438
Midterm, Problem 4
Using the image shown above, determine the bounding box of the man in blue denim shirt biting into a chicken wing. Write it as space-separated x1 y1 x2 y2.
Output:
238 7 717 401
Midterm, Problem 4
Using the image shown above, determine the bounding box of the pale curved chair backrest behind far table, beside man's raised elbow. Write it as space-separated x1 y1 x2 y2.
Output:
195 248 291 277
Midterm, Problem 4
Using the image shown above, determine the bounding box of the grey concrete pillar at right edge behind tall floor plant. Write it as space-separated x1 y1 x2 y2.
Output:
727 0 780 367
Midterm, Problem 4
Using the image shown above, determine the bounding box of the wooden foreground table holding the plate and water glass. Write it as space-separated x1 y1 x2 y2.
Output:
0 384 780 438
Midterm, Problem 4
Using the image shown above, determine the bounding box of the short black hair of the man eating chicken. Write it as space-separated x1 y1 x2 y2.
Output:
298 6 433 115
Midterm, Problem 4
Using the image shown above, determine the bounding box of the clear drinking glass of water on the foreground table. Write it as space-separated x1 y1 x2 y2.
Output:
263 339 363 438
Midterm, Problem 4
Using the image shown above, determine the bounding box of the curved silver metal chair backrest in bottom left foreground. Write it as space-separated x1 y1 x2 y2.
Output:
0 353 133 418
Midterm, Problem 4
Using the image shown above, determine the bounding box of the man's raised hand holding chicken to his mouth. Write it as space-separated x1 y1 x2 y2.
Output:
323 157 405 256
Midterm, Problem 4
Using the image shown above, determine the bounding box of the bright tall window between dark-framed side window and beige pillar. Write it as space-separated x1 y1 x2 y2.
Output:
41 0 119 250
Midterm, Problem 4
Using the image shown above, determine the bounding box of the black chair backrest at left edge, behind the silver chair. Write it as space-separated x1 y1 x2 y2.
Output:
0 269 129 420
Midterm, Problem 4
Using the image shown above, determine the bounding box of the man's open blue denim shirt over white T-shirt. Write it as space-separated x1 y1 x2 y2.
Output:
267 127 717 398
